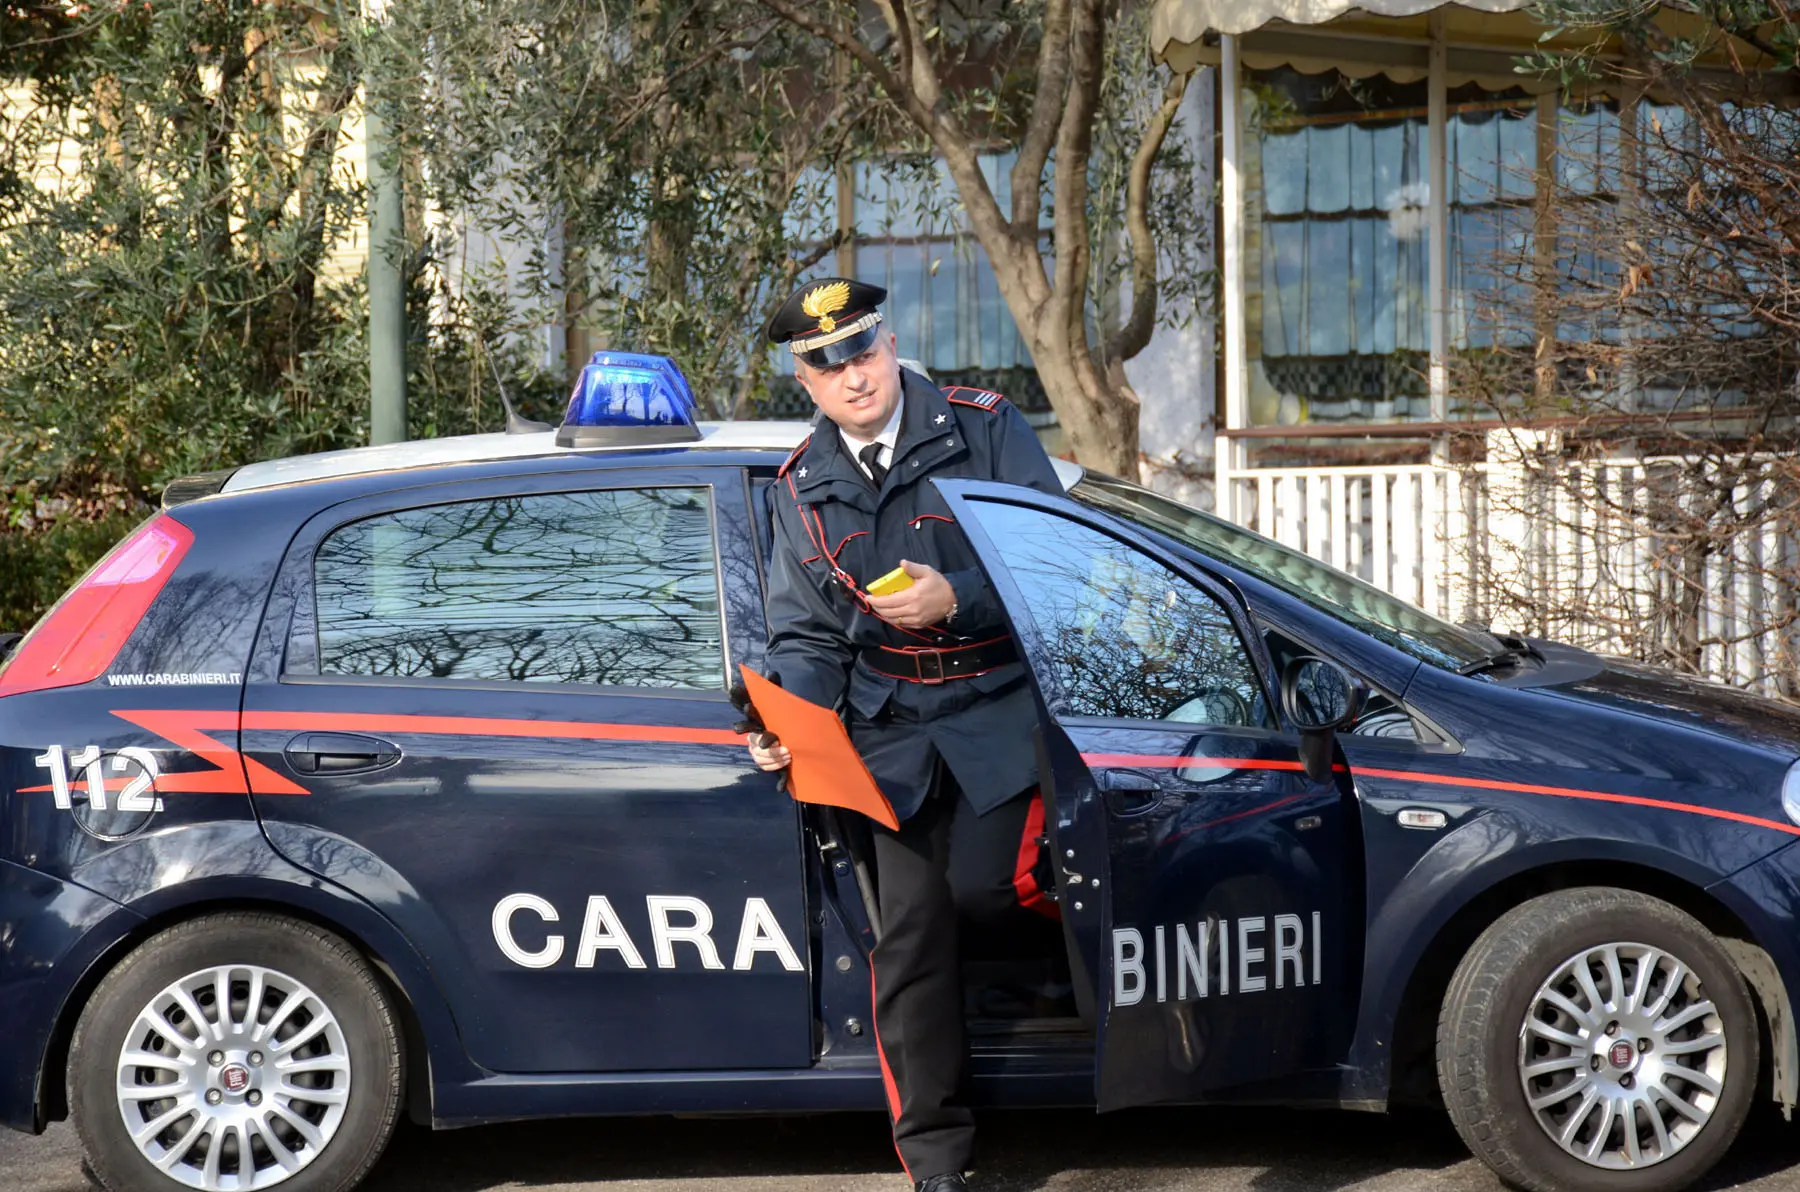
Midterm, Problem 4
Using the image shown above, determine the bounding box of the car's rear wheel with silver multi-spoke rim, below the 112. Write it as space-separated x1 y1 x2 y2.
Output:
68 911 405 1192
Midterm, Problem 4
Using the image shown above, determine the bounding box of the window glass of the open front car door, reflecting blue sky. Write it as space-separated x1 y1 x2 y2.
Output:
981 504 1269 727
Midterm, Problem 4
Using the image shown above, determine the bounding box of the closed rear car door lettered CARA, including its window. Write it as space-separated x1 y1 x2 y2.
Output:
243 470 812 1073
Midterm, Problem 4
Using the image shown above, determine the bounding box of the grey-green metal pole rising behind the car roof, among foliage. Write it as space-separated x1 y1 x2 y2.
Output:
362 0 407 443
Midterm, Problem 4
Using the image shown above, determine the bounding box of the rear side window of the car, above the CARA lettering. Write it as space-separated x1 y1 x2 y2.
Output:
313 488 725 690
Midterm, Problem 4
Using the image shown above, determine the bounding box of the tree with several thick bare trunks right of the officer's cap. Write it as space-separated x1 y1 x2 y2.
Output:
760 0 1202 477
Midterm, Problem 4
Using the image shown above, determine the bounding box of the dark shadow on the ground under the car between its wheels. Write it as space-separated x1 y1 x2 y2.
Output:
358 1109 1469 1192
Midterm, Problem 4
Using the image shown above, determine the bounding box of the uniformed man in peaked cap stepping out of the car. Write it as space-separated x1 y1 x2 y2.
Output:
751 277 1060 1192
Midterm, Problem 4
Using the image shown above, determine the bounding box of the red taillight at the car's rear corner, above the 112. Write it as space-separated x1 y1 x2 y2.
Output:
0 513 194 695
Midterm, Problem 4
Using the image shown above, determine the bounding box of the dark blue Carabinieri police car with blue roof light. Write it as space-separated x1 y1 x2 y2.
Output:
0 353 1800 1192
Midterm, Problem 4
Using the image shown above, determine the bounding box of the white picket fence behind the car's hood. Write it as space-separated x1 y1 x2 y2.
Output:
1226 450 1800 697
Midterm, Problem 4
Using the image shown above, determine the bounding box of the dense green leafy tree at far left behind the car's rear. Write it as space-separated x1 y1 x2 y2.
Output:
0 0 547 628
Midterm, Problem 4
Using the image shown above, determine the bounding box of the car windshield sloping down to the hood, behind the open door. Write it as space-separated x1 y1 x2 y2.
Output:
1069 472 1499 670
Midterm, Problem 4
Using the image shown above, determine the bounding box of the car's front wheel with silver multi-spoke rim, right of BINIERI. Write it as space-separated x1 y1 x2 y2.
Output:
1438 888 1760 1192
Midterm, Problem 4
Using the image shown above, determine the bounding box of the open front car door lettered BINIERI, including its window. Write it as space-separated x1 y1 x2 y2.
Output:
938 481 1363 1109
